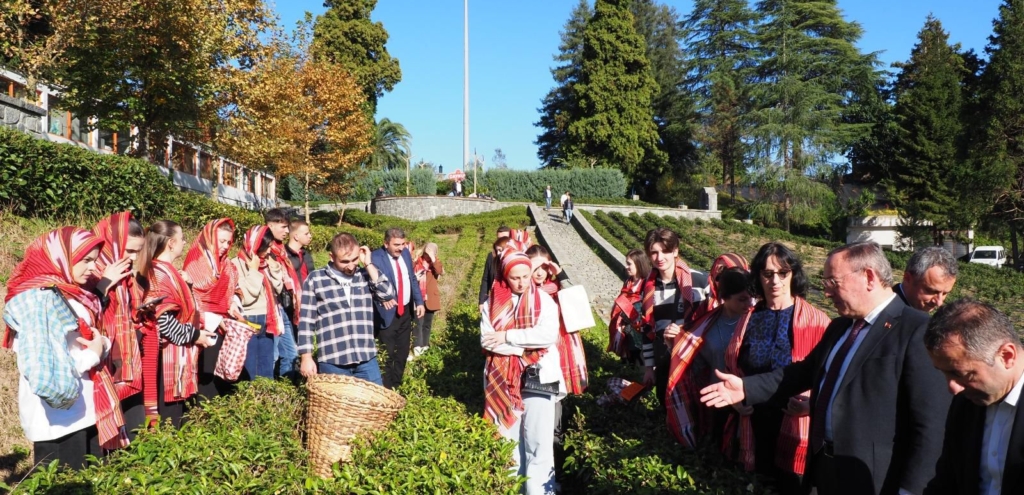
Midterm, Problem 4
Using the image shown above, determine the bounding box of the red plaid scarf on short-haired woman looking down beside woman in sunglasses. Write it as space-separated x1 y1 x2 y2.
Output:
666 306 751 449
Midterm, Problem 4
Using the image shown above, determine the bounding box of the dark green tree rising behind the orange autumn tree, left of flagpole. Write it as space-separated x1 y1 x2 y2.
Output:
313 0 401 115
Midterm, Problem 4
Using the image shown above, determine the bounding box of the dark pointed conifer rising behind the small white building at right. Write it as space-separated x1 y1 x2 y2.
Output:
883 15 969 236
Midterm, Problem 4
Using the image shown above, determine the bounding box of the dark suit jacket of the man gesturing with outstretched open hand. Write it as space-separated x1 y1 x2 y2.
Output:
743 297 950 495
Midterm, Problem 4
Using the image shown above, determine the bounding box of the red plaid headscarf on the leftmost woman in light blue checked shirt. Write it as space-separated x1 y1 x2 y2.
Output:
3 226 128 450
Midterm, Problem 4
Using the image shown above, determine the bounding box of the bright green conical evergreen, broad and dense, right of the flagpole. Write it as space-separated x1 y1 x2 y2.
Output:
566 0 667 180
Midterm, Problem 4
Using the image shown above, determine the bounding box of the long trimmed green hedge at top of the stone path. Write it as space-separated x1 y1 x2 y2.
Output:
481 168 626 203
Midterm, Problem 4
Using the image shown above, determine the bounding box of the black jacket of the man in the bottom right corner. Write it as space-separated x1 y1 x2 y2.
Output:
925 387 1024 495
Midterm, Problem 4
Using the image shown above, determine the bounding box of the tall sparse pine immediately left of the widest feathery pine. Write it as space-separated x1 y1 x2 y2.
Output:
682 0 757 196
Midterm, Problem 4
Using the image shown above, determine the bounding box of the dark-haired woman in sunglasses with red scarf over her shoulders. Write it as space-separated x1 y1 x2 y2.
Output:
725 242 829 494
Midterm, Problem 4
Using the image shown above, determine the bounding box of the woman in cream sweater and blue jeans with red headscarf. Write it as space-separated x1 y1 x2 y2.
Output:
231 225 288 379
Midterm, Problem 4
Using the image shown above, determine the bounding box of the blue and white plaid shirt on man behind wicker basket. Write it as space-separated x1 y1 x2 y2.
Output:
298 265 395 366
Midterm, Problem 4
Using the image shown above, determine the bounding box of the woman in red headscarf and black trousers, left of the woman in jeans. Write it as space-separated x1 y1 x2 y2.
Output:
184 218 244 399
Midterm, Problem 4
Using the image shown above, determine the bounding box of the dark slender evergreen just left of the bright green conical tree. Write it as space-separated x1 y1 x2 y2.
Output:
534 0 593 167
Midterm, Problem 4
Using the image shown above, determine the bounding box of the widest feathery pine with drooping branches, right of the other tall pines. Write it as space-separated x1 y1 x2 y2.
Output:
750 0 879 230
